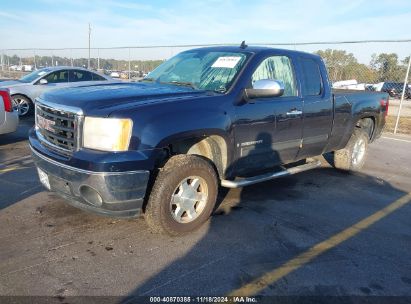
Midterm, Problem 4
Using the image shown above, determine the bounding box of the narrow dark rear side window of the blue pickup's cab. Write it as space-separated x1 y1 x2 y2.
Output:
301 58 322 96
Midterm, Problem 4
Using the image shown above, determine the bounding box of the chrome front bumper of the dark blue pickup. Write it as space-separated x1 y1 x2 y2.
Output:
31 147 150 217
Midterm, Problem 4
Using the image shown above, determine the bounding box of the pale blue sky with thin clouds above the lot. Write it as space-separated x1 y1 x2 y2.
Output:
0 0 411 60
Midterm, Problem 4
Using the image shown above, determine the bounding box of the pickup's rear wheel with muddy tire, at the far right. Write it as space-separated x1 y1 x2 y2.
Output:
334 128 369 171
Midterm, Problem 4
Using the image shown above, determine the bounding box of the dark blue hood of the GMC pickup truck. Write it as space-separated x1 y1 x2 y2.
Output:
39 83 208 116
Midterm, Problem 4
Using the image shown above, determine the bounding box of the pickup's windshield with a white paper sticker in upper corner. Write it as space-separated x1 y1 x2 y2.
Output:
143 50 249 93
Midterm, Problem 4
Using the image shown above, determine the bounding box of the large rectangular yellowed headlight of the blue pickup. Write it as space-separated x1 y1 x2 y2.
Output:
83 117 133 151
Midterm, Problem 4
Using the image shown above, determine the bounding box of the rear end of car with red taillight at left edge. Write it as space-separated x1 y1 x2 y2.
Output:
0 89 19 134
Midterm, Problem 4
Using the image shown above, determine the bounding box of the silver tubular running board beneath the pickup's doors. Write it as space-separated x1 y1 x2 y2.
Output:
221 160 321 188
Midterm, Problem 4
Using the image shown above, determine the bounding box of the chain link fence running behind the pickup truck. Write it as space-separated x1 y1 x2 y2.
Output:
0 40 411 134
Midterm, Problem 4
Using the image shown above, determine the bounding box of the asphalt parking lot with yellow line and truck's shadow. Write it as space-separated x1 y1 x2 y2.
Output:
0 120 411 303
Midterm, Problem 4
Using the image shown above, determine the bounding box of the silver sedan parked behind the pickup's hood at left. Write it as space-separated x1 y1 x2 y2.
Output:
0 66 119 117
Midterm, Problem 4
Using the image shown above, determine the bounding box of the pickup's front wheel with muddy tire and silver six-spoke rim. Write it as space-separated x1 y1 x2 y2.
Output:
145 155 218 236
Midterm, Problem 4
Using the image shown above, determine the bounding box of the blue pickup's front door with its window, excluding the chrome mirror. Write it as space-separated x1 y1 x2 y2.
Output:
234 55 303 175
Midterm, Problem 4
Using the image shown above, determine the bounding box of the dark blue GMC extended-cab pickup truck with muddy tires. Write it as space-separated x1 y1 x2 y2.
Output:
30 45 388 235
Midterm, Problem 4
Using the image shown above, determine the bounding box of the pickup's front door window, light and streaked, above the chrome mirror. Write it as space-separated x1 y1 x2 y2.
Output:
251 56 297 96
